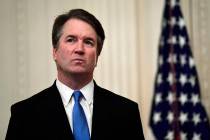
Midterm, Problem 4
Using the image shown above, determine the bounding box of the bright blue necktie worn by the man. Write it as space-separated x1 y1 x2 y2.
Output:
73 91 90 140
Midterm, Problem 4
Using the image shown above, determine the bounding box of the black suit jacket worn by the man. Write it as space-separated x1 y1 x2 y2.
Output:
6 83 144 140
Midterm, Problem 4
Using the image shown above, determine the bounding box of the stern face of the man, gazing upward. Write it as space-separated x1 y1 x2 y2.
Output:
53 19 97 75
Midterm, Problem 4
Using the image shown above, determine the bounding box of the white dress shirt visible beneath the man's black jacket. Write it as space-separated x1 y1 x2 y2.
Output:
56 80 94 134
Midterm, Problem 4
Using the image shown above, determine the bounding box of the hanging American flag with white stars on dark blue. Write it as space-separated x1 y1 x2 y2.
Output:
150 0 210 140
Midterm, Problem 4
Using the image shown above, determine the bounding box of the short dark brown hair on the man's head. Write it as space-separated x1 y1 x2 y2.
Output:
52 9 105 55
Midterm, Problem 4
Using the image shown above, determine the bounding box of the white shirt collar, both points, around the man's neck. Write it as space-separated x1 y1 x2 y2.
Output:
56 79 94 106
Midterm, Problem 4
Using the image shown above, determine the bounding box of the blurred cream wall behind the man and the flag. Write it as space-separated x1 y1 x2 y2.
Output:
0 0 210 140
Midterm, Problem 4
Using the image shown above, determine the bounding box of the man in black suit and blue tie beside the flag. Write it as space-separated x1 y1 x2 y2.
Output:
6 9 144 140
